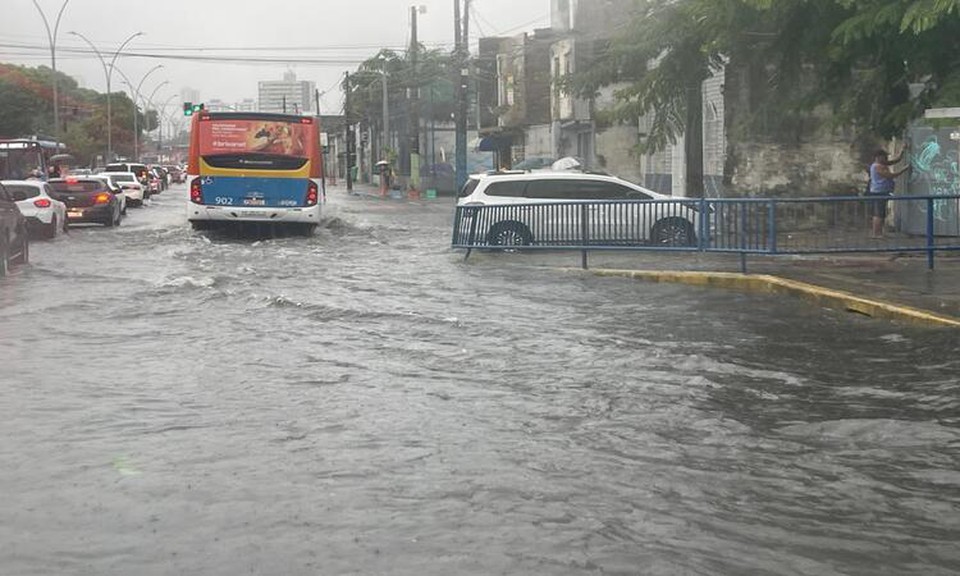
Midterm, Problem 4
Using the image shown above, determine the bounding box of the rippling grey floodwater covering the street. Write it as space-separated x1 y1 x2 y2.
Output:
0 188 960 576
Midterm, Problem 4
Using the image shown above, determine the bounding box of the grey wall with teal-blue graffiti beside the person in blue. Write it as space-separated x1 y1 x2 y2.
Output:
900 125 960 236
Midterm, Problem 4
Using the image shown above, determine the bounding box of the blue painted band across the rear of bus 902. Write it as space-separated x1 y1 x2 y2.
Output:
201 176 310 208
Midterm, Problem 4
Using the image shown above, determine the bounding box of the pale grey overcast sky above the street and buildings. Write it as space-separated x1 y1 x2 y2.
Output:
0 0 550 113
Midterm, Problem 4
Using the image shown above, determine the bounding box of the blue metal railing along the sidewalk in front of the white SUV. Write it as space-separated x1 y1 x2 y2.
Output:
452 196 960 271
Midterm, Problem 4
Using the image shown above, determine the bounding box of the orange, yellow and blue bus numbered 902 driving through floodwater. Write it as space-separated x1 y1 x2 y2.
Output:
187 112 323 234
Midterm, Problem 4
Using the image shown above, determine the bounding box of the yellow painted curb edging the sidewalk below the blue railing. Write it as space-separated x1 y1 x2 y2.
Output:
568 269 960 328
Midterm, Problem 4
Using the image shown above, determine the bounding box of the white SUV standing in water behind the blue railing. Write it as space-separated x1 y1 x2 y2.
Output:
457 171 700 247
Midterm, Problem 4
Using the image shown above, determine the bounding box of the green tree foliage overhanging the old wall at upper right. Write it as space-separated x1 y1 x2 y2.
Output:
565 0 960 152
